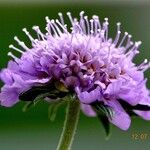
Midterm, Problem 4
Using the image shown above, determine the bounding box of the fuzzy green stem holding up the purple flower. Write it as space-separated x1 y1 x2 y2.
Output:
57 100 80 150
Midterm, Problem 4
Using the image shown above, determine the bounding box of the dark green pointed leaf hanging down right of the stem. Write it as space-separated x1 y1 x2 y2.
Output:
92 102 113 138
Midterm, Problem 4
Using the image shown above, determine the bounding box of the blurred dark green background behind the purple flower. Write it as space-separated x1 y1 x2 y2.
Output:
0 0 150 150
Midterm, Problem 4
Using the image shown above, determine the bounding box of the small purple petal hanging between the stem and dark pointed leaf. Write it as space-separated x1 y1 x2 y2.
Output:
80 103 96 117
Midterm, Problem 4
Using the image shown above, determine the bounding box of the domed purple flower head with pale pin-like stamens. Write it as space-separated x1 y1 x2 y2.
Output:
0 11 150 130
